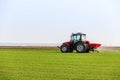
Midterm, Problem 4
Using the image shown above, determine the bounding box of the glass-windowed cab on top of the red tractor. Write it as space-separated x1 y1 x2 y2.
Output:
70 33 86 44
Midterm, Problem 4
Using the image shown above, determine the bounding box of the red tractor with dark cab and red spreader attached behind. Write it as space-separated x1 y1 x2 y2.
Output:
60 33 101 53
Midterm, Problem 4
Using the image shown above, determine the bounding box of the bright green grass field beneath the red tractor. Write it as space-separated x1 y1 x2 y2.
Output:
0 49 120 80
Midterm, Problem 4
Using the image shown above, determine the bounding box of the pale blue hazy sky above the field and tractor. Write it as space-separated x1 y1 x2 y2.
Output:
0 0 120 46
